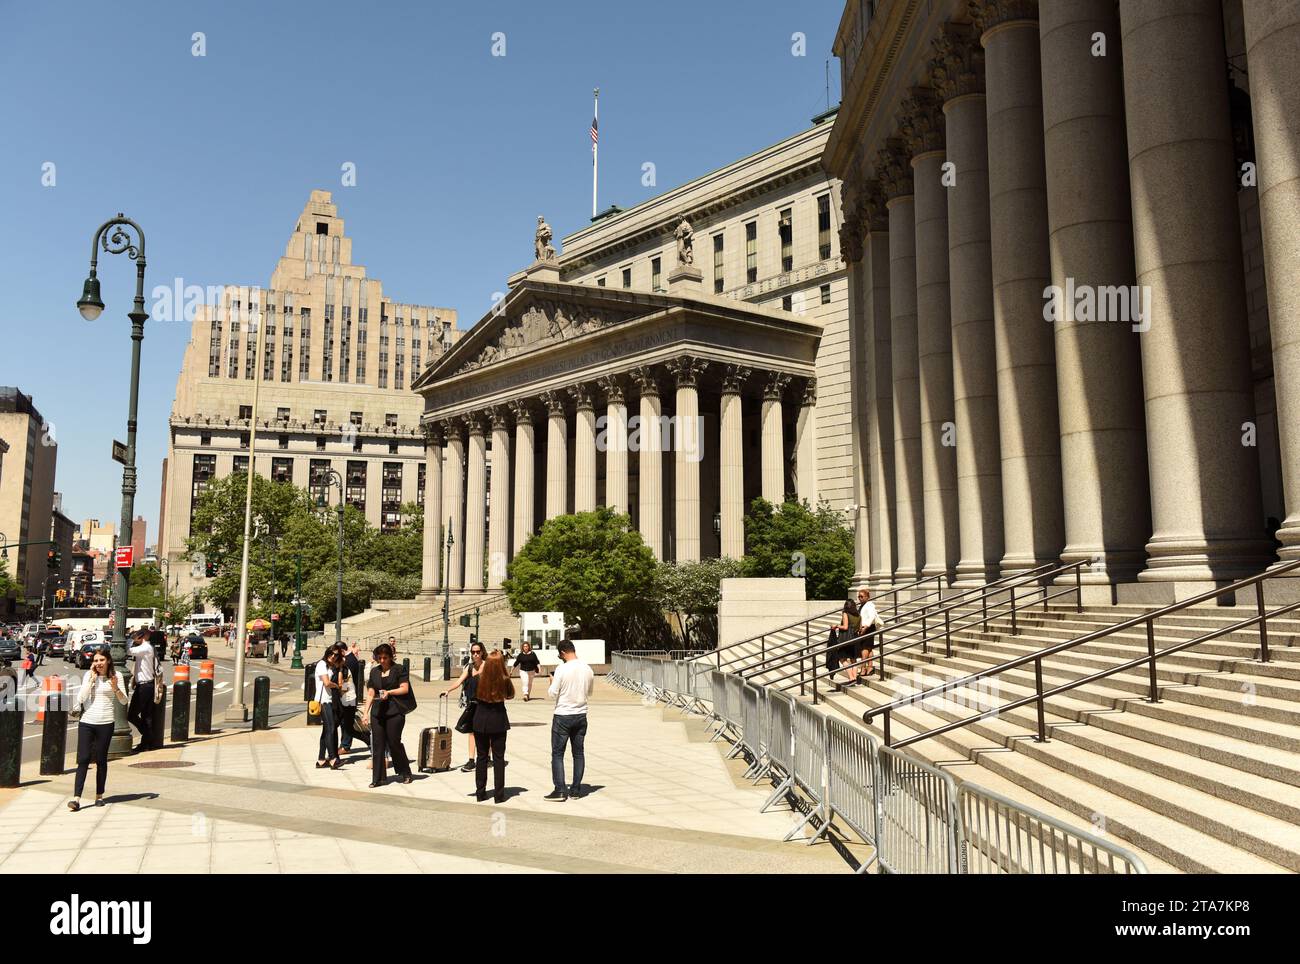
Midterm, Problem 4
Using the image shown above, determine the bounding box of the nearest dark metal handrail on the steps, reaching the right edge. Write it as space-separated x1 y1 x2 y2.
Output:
862 560 1300 747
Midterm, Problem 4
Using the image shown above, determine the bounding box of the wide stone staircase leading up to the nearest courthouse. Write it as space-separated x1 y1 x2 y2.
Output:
826 605 1300 873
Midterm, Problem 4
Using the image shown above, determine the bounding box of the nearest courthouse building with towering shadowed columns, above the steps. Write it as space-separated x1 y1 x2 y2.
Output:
824 0 1300 602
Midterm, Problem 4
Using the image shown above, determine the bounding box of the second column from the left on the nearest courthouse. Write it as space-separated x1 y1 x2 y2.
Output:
862 182 898 589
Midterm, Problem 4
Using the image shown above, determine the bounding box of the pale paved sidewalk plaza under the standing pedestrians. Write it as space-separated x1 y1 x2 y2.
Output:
0 679 849 873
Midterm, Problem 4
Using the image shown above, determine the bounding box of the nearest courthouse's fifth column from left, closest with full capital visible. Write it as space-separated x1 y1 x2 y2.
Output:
931 23 1004 589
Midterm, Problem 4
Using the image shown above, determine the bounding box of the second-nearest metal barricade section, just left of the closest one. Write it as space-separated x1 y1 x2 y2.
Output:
876 747 961 873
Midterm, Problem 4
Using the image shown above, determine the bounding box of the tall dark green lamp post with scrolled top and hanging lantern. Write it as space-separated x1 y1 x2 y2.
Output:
77 212 150 759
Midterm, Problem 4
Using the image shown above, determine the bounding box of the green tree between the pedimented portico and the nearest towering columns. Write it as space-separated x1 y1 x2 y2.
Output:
741 499 854 599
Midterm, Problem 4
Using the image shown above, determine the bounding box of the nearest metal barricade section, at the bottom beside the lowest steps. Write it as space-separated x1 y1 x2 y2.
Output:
957 783 1147 874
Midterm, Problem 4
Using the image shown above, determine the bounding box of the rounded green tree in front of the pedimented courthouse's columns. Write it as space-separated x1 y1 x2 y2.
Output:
503 507 658 647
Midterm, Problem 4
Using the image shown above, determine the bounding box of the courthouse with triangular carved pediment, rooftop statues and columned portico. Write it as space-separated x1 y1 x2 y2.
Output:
415 113 854 592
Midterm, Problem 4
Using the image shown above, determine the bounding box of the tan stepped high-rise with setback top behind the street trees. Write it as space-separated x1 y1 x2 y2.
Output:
159 191 460 592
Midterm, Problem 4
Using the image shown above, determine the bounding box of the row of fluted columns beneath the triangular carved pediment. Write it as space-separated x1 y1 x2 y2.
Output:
423 355 816 594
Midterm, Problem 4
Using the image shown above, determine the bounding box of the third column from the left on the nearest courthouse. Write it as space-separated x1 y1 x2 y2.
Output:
876 138 926 582
